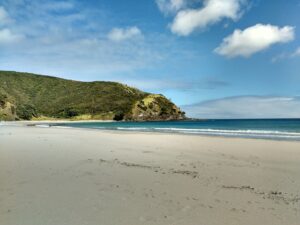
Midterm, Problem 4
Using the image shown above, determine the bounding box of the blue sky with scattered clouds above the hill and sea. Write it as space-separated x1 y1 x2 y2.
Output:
0 0 300 118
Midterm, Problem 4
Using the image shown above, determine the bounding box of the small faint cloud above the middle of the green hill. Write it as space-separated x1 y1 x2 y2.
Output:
107 27 142 42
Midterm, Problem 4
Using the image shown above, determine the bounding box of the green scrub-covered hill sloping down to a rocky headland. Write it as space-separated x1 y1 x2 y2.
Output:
0 71 185 121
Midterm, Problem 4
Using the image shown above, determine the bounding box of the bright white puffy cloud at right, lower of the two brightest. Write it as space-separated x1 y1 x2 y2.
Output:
215 24 295 57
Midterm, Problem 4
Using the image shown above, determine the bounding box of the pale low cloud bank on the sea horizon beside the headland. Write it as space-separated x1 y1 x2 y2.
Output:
182 96 300 119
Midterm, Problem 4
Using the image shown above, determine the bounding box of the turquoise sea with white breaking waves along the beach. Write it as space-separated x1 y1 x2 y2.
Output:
55 119 300 141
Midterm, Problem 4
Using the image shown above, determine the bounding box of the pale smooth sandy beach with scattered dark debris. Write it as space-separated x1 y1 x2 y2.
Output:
0 126 300 225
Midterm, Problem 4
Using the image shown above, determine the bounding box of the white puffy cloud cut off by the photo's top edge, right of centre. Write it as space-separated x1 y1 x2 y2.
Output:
171 0 245 36
